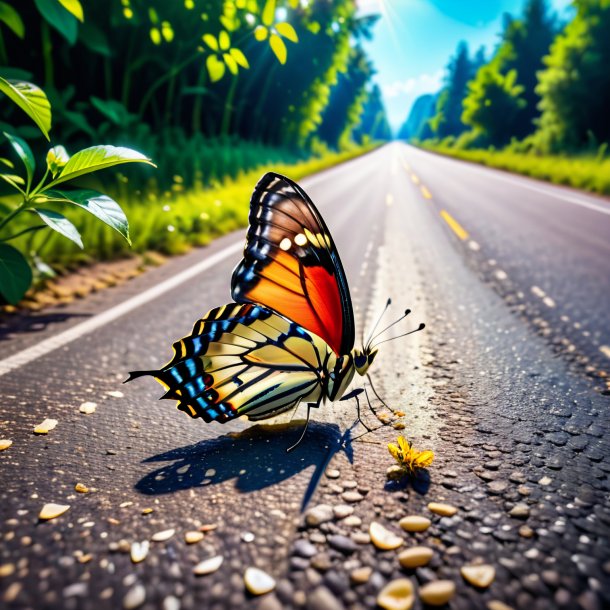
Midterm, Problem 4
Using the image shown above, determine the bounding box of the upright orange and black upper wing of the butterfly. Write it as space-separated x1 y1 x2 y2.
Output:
231 173 354 356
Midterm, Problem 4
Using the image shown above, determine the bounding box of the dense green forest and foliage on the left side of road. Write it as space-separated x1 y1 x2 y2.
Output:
0 0 391 303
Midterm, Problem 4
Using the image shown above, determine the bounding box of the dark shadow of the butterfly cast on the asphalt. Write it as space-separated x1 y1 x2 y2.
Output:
135 421 353 510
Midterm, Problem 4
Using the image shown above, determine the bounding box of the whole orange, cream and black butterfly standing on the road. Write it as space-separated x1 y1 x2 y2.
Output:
127 172 424 446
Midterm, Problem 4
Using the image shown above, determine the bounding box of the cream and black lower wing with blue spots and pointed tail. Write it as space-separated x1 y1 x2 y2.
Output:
125 304 330 423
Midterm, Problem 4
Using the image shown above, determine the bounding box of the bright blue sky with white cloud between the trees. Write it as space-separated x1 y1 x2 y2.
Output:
358 0 570 131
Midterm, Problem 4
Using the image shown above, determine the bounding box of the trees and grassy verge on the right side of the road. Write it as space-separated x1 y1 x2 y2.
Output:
400 0 610 194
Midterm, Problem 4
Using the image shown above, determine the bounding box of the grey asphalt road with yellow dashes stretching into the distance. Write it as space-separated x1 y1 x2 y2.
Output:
0 144 610 610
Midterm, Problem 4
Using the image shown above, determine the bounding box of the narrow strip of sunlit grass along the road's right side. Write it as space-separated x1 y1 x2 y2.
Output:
419 142 610 195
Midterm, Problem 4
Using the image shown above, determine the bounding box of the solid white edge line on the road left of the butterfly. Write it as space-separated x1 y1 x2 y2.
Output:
0 240 244 377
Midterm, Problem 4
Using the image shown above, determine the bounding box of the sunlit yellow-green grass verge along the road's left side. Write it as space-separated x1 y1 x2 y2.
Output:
13 144 377 270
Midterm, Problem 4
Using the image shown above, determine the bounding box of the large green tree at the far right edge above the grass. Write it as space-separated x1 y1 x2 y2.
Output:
536 0 610 150
